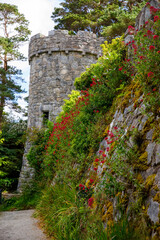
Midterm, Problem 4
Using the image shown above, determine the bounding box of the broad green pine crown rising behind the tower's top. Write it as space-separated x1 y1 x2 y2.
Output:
51 0 146 37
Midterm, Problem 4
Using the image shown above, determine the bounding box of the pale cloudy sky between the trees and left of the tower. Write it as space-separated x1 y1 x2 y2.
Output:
0 0 62 117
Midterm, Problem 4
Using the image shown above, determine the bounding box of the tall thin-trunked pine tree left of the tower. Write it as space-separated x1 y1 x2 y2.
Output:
0 3 30 129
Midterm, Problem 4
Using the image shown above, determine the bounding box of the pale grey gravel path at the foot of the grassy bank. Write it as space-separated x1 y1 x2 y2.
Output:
0 210 47 240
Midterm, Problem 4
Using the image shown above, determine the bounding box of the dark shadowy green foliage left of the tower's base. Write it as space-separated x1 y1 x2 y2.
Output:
0 120 26 191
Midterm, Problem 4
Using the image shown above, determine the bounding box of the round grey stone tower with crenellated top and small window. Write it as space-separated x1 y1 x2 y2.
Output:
18 30 104 191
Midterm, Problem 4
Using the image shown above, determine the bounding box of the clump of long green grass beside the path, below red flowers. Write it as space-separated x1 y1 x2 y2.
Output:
37 182 107 240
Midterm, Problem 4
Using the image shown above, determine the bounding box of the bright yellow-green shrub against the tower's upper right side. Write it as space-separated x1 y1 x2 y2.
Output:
74 37 127 90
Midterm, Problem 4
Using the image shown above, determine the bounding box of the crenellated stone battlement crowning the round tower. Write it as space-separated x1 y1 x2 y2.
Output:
29 30 105 62
